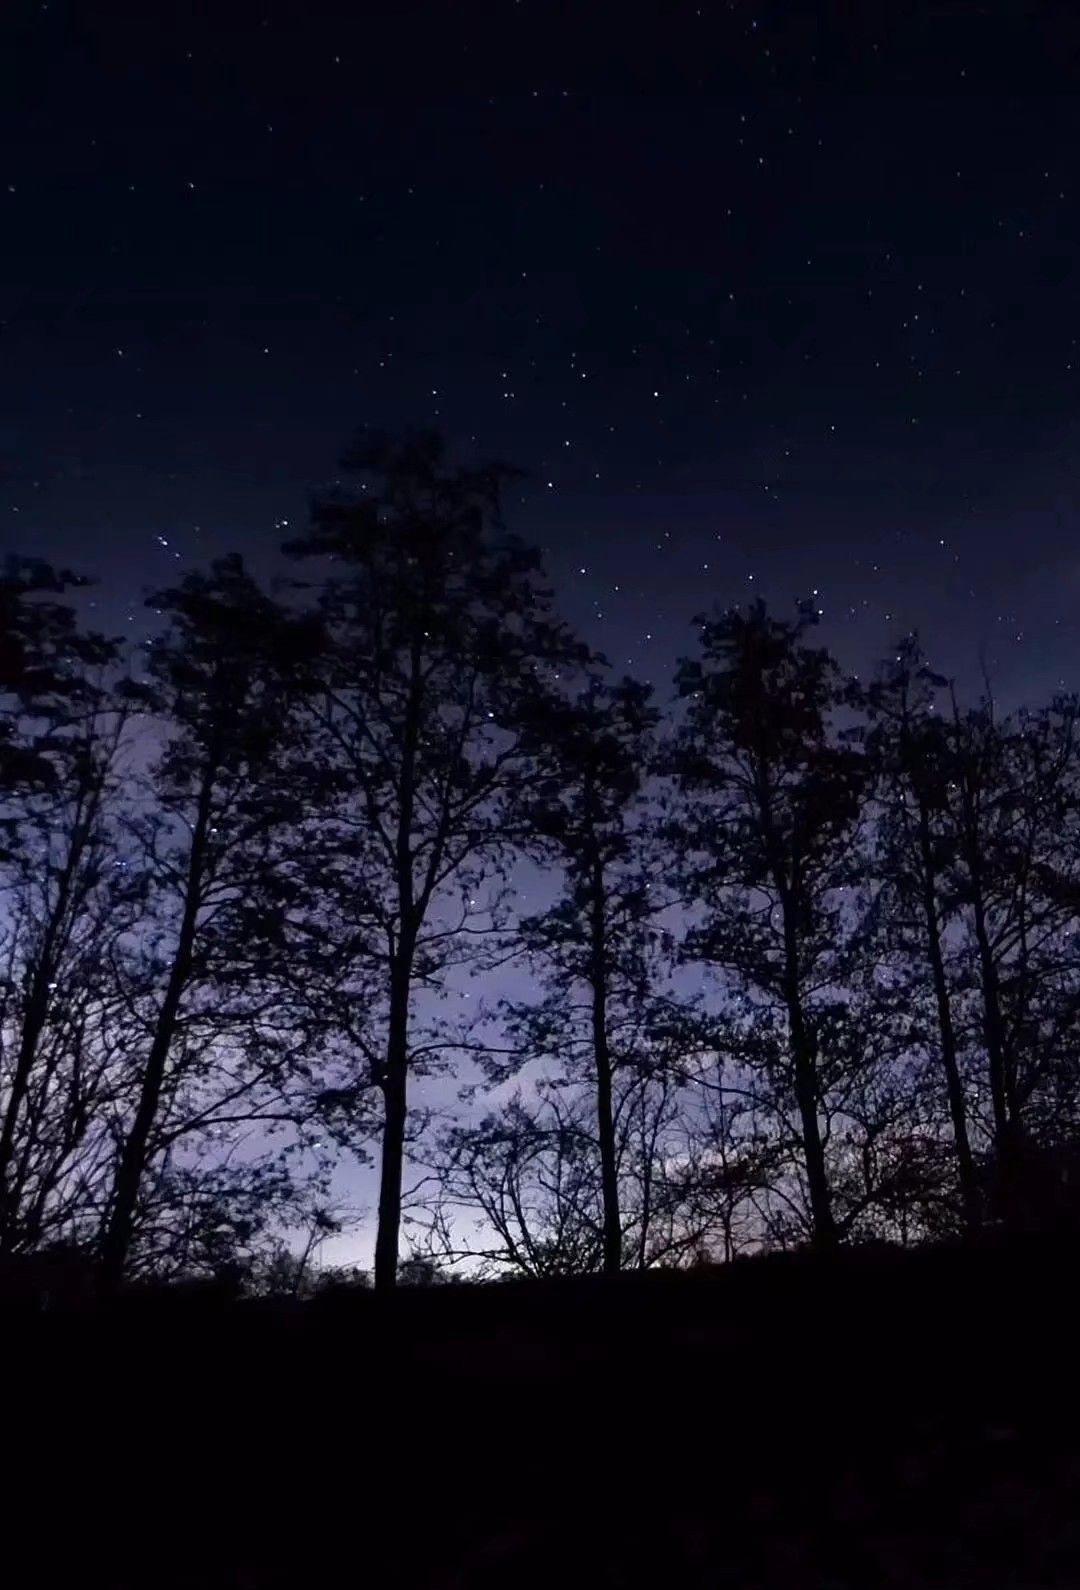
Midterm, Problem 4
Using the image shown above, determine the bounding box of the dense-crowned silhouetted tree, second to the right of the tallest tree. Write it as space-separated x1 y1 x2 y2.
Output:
671 603 865 1248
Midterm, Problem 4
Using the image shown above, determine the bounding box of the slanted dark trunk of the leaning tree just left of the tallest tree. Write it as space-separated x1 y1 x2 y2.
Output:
102 765 216 1291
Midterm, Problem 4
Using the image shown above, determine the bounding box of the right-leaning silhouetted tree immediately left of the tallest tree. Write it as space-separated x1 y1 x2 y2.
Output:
102 557 318 1285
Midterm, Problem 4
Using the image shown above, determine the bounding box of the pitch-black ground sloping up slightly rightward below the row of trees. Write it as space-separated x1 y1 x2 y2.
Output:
12 1240 1080 1590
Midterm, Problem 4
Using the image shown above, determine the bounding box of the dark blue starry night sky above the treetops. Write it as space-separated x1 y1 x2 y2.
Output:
0 0 1080 1252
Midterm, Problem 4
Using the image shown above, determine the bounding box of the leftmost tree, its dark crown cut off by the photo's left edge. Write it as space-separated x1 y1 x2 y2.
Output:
0 560 140 1253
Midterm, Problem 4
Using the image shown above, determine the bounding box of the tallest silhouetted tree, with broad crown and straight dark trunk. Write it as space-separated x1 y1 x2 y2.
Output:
278 434 576 1288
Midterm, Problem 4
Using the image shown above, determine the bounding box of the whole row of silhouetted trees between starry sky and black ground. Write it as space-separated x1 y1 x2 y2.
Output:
0 434 1080 1288
